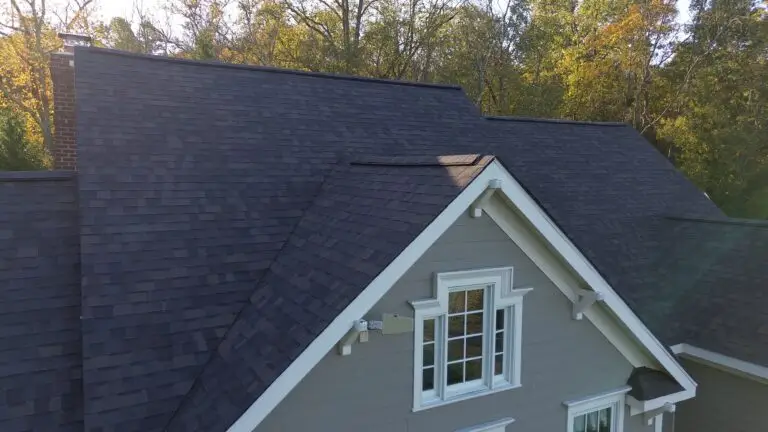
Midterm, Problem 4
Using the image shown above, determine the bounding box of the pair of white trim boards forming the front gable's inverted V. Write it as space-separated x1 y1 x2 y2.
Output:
227 161 696 432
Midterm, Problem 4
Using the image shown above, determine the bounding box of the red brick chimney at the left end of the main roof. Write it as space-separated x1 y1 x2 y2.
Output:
49 33 91 171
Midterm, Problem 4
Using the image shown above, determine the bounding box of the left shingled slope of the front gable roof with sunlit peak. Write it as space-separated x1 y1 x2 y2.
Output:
167 155 493 431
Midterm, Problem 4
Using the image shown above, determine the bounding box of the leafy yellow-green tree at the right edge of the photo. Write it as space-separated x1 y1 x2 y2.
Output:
658 0 768 218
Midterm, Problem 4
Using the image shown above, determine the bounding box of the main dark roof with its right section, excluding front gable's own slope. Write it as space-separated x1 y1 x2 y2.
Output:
76 48 722 431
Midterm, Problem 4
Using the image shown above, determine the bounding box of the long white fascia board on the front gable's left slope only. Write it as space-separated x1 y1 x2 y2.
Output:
227 162 505 432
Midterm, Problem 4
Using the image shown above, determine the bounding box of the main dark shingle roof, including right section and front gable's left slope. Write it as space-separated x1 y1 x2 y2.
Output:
7 45 756 431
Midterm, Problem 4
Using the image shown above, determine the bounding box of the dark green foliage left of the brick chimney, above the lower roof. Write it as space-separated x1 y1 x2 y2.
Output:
0 112 45 171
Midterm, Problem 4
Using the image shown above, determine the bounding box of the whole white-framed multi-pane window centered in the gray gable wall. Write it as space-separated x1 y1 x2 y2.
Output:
412 267 531 410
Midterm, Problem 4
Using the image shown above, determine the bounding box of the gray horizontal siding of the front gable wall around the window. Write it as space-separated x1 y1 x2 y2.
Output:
257 208 648 432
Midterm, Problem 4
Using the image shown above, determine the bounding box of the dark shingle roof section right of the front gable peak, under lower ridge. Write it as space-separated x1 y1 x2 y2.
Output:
480 117 727 343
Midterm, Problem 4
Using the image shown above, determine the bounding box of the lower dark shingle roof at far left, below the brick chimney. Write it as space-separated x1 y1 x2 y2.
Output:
0 172 83 432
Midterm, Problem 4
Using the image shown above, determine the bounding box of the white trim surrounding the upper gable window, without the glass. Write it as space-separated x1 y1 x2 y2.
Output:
411 267 533 411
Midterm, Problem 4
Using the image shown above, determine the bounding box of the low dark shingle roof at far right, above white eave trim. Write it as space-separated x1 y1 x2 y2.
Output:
645 217 768 365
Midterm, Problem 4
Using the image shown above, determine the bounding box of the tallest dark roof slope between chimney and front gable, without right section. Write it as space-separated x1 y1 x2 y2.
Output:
75 48 486 431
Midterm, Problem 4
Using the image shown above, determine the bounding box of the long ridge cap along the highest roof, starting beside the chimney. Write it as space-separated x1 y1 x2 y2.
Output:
75 47 462 90
